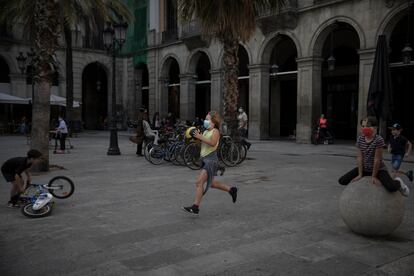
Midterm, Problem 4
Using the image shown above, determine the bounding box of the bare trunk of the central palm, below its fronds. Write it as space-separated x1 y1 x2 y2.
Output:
223 41 239 138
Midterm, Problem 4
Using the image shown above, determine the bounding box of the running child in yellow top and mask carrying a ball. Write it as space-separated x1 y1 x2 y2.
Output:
182 111 237 215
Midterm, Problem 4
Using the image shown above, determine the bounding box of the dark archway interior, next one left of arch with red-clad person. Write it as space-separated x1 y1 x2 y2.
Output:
269 35 297 137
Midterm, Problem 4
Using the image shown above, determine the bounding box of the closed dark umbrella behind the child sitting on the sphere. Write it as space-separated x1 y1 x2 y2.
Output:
367 35 393 137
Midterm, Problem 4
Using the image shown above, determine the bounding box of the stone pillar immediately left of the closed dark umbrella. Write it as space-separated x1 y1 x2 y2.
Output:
356 48 375 128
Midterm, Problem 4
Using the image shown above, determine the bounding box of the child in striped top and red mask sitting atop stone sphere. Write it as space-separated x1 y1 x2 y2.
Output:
338 117 410 196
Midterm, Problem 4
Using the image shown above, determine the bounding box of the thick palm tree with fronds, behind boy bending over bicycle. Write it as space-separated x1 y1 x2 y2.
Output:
0 0 130 170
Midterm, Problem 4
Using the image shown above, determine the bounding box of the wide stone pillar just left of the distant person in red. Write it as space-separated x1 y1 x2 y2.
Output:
296 57 323 143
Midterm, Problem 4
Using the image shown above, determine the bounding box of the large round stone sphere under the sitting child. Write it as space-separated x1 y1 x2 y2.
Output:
339 177 405 236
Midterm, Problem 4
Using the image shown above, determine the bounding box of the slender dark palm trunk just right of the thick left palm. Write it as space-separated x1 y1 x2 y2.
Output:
63 25 74 132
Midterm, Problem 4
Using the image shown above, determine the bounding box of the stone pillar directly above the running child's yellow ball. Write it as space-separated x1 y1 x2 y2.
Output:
180 74 196 121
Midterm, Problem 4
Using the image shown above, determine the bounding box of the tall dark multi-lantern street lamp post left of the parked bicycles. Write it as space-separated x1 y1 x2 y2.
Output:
103 22 128 155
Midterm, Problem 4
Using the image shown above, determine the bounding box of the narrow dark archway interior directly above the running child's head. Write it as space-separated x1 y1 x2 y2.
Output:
195 53 211 118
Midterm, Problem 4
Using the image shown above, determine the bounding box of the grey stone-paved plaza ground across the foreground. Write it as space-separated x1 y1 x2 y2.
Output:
0 132 414 276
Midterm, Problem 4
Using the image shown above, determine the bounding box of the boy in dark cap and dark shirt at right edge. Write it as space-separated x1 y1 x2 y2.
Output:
388 123 413 182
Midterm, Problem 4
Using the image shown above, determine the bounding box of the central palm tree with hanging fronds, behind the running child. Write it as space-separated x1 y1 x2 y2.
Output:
178 0 286 137
